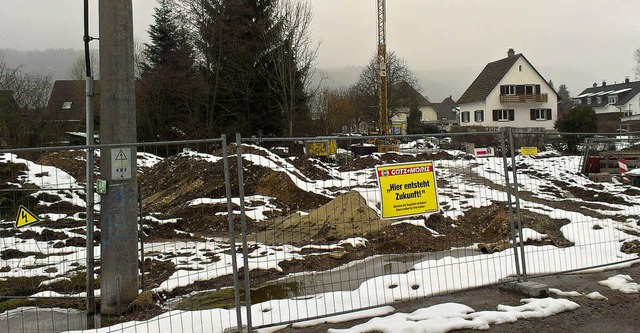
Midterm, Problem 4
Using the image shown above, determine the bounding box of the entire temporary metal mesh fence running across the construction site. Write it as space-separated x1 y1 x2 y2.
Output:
0 129 640 332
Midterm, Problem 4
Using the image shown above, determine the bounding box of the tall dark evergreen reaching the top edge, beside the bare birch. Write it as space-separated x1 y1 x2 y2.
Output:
197 0 282 134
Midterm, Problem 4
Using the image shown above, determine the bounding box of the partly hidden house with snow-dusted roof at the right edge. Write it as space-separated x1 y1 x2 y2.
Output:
573 78 640 133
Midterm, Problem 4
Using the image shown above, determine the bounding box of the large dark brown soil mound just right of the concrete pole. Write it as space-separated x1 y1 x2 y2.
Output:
139 149 331 238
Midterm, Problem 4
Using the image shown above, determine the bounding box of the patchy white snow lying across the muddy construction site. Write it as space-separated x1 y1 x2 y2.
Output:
0 143 640 332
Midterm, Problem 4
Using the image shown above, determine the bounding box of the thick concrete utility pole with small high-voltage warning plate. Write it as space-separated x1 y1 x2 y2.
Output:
99 0 138 315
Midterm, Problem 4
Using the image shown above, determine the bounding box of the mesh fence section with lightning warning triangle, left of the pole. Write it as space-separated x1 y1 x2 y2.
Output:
0 149 94 332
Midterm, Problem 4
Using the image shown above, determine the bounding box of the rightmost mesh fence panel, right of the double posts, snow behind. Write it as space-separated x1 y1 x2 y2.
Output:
513 131 640 275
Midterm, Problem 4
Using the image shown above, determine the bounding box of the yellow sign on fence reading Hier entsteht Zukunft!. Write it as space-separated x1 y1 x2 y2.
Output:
376 161 440 218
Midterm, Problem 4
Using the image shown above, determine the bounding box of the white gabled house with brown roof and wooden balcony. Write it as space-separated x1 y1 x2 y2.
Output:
458 49 558 130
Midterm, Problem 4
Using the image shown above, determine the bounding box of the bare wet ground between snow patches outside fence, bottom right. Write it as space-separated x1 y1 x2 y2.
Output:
279 264 640 333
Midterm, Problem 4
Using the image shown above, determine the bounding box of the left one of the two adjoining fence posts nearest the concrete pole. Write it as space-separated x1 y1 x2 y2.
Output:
222 134 242 332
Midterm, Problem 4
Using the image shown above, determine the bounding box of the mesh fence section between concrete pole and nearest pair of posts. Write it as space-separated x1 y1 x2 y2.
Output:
132 139 241 332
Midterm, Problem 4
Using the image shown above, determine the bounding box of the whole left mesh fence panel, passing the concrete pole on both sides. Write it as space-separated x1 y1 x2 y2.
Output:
0 139 239 332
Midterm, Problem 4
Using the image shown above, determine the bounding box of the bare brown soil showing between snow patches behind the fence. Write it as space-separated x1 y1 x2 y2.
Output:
0 148 640 320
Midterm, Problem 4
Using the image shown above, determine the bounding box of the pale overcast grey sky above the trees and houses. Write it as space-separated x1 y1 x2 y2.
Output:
0 0 640 96
